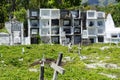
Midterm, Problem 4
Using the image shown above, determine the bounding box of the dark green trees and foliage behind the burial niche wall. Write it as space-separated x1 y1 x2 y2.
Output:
0 0 120 27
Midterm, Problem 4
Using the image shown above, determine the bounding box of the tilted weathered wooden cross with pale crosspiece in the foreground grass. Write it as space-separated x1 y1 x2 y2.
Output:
51 53 65 80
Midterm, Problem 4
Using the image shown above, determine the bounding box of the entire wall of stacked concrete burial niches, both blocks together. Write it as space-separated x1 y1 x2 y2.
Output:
28 9 105 44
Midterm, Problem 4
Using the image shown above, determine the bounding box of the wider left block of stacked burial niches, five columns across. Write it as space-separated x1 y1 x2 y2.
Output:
28 9 81 44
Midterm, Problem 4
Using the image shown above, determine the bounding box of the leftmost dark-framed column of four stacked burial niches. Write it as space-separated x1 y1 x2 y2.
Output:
28 10 39 44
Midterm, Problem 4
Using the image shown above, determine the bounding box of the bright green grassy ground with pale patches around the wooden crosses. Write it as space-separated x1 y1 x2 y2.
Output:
0 44 120 80
